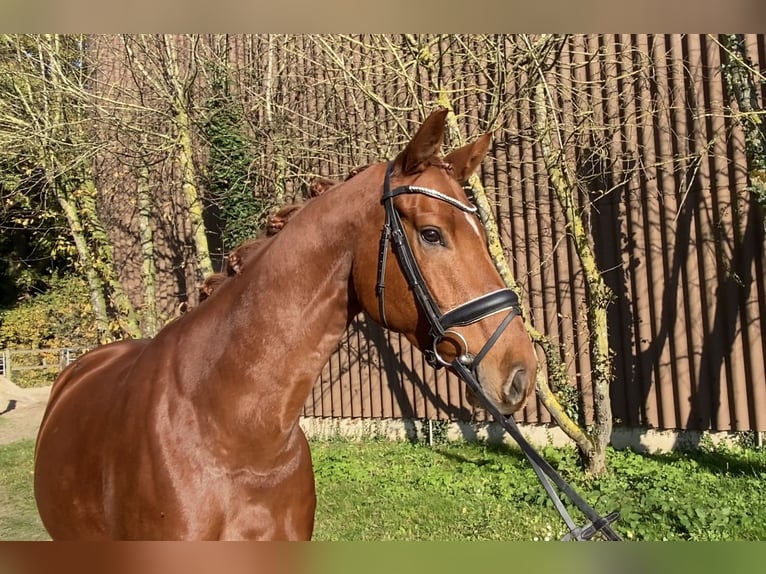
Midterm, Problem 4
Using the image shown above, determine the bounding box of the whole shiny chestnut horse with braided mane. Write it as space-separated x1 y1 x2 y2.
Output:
35 110 537 540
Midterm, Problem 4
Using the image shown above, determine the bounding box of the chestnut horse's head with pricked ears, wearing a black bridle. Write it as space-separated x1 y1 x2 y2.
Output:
353 110 537 414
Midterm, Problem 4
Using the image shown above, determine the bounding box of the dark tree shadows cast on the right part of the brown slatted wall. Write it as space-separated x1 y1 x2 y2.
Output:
591 154 764 449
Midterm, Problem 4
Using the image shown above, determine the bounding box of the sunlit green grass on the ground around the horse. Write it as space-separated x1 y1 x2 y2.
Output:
0 440 766 541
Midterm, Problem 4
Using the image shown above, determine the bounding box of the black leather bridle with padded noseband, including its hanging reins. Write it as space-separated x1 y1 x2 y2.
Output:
376 162 622 540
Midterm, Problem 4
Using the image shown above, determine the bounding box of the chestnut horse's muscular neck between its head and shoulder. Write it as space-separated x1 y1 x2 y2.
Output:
175 179 380 450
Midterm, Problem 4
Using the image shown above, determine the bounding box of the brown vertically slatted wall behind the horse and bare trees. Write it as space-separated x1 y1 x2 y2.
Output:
94 34 766 431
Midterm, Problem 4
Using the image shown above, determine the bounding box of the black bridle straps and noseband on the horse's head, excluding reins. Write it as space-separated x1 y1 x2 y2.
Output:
376 162 520 374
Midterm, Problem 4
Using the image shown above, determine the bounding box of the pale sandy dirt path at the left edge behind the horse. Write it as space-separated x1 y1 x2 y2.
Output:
0 377 51 445
